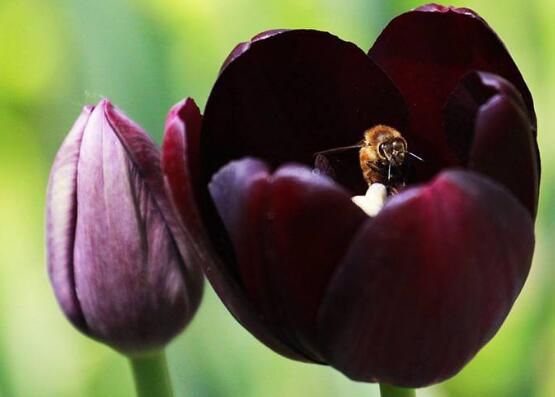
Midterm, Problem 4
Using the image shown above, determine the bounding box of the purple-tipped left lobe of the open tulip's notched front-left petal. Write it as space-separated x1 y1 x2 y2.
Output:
209 159 315 361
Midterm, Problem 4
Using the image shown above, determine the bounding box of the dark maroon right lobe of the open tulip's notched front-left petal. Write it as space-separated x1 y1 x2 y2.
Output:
258 165 368 354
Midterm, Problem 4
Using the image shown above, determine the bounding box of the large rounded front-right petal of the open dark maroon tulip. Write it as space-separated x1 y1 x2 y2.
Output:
320 171 534 387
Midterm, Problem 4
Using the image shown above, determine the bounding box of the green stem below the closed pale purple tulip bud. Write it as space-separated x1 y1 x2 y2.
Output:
129 350 173 397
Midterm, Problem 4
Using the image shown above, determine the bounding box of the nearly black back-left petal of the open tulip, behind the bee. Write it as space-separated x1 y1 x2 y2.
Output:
200 30 406 196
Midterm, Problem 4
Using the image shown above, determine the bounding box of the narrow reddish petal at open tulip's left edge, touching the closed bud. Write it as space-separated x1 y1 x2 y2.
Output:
162 103 306 360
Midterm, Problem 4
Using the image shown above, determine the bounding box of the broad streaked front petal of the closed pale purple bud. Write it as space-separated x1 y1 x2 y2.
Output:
74 100 195 353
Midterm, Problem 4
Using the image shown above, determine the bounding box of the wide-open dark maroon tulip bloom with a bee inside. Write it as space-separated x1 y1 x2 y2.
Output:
163 4 540 387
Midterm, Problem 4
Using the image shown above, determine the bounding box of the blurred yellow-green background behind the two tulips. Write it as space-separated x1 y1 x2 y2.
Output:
0 0 555 397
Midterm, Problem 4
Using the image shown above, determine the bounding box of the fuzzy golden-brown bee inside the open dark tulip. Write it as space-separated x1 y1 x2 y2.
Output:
314 124 424 194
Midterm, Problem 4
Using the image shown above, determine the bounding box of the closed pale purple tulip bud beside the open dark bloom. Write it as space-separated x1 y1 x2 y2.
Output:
46 100 203 354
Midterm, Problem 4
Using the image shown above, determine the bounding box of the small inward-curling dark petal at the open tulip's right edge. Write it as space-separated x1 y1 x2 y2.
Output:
444 72 540 217
